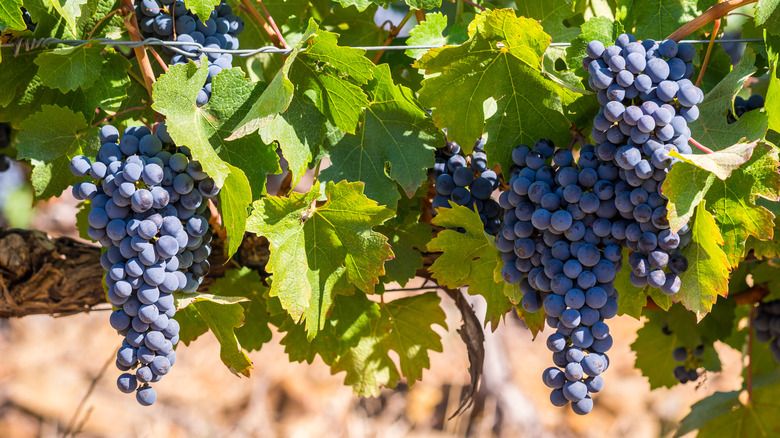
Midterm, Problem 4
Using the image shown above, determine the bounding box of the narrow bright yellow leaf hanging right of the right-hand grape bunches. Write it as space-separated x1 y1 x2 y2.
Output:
677 201 730 320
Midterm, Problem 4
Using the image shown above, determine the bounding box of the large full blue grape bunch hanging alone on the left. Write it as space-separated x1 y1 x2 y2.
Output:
70 123 219 406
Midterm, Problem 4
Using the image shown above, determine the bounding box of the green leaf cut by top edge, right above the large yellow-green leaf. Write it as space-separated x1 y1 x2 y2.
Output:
515 0 581 42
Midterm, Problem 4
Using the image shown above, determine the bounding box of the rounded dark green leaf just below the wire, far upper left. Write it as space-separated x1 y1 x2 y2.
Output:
34 45 105 93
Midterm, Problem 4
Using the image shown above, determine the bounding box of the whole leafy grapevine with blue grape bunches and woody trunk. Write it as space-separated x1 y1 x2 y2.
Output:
0 0 780 438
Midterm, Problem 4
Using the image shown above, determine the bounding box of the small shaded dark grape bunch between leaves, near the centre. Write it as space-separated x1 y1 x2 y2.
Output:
431 139 501 235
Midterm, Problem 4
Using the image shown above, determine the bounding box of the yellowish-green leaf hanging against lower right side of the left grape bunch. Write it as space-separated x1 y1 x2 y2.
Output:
209 268 272 351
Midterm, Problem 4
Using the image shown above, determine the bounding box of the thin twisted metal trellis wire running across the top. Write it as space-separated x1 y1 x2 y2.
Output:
0 38 764 57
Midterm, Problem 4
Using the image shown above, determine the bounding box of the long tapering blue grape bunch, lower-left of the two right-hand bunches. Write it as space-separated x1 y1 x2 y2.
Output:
496 139 623 415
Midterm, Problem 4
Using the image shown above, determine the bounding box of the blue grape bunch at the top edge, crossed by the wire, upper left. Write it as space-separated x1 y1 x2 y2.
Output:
136 0 244 106
